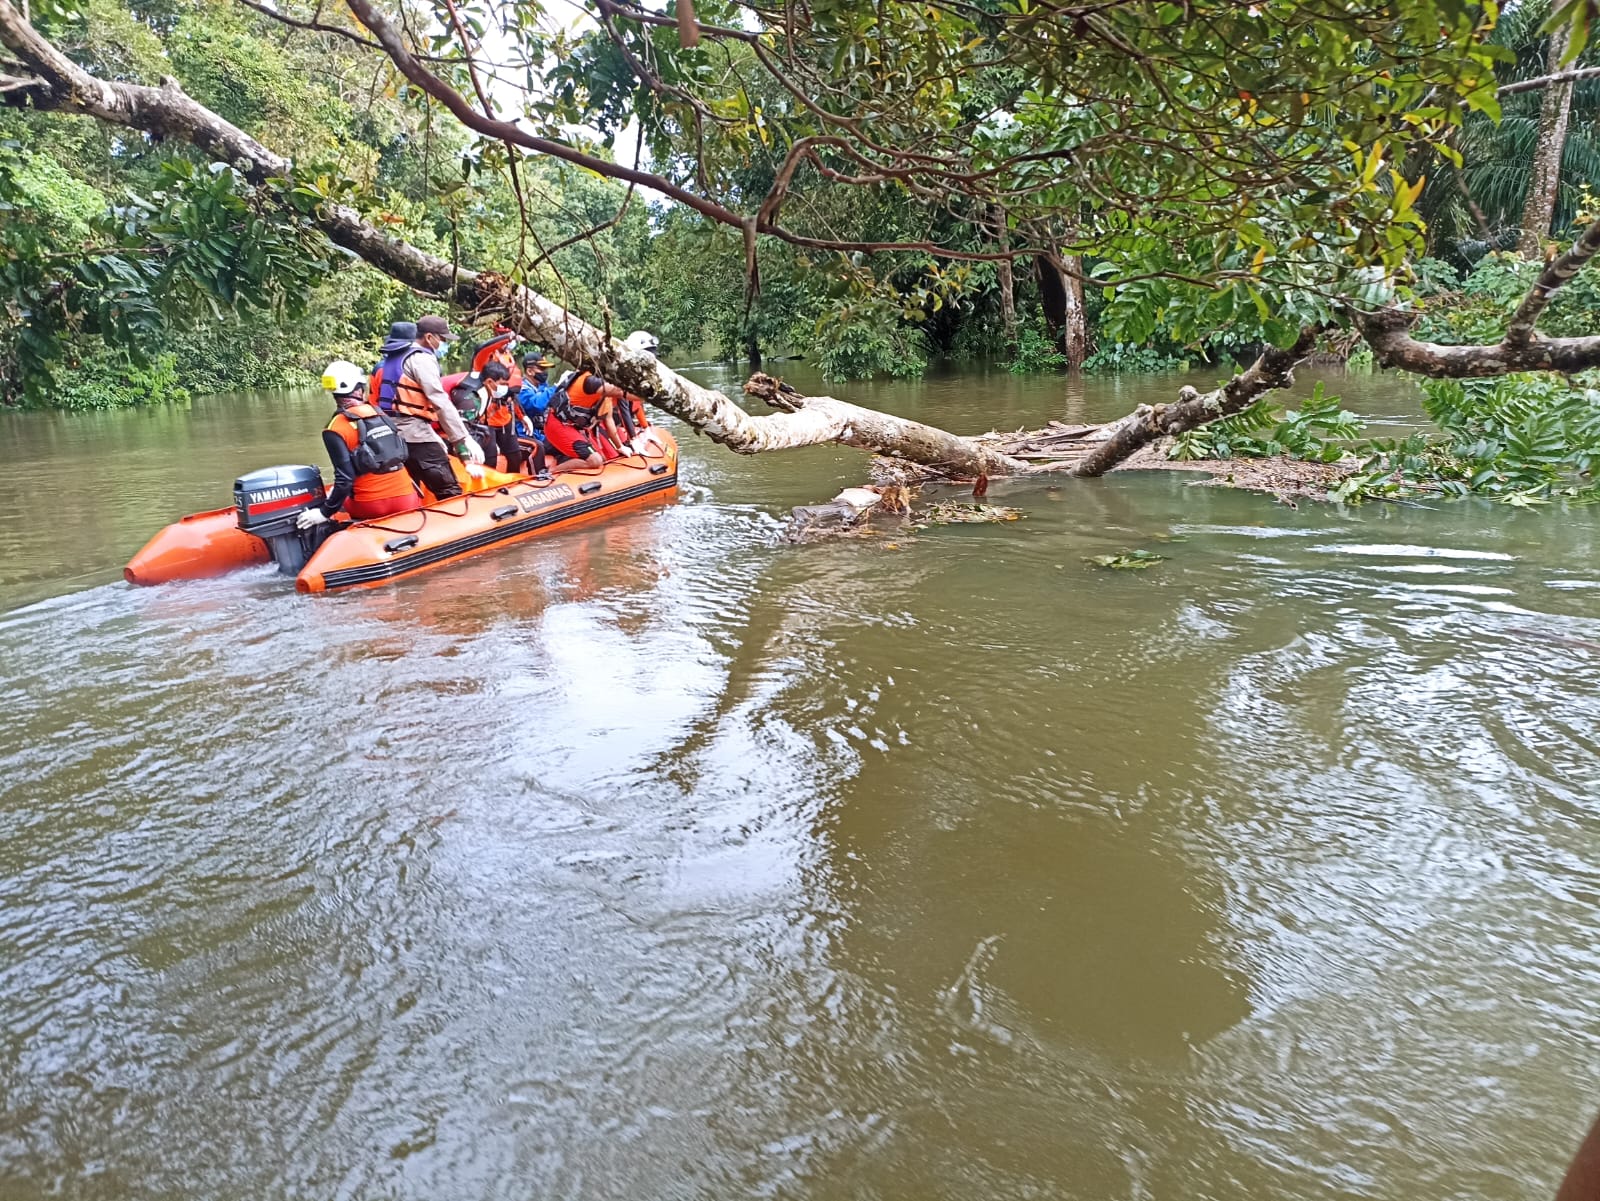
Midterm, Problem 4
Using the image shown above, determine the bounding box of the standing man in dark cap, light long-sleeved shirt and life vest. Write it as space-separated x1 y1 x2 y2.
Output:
368 317 483 501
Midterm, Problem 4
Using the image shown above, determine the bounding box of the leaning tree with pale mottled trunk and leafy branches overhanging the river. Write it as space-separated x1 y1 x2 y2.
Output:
0 0 1600 473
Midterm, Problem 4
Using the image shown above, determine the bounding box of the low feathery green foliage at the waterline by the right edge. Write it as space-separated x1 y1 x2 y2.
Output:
1334 376 1600 505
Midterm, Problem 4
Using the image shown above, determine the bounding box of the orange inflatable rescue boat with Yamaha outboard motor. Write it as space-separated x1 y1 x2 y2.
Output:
122 438 678 592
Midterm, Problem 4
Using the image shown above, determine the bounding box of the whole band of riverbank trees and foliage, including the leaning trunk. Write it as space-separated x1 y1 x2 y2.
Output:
0 0 1600 489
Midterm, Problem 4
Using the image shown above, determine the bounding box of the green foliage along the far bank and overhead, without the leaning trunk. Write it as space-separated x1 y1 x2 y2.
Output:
12 0 1600 409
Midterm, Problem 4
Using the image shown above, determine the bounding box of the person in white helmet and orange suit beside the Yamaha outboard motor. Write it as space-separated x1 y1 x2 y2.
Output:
294 358 422 529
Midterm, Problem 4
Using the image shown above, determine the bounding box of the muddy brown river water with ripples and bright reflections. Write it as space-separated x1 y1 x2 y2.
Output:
0 368 1600 1201
